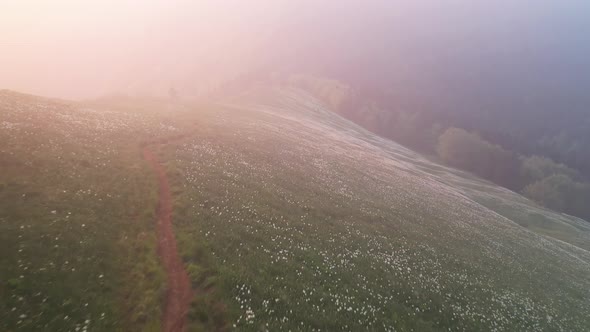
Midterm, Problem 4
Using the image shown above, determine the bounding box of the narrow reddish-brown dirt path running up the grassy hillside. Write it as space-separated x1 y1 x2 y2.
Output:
143 146 192 332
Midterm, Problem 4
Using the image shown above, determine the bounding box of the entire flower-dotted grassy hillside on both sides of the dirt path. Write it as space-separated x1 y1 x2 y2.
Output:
0 88 590 331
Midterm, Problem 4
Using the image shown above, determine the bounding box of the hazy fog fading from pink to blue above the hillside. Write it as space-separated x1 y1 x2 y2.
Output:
0 0 590 103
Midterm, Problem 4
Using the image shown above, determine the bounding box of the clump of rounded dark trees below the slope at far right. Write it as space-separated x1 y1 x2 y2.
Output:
436 128 590 220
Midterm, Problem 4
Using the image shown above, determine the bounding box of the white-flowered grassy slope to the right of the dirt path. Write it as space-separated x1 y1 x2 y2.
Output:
164 89 590 331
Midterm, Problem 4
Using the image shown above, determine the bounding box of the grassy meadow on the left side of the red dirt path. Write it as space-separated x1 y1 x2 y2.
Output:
0 91 176 331
